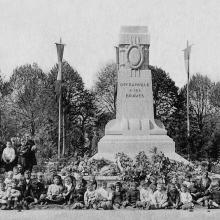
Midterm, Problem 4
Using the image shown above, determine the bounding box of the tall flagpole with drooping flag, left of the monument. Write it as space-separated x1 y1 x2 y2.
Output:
56 38 64 159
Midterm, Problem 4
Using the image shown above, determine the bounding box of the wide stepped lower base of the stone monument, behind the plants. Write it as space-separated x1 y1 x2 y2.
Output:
93 135 189 163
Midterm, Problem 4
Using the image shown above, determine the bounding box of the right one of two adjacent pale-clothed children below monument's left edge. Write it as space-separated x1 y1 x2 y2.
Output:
96 181 112 209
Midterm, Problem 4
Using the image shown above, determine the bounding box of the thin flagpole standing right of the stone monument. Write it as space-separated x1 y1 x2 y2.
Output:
186 40 190 161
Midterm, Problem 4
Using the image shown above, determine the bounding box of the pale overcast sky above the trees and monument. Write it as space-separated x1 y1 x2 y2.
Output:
0 0 220 87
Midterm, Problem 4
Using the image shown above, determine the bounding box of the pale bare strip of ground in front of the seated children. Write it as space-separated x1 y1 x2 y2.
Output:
0 209 220 220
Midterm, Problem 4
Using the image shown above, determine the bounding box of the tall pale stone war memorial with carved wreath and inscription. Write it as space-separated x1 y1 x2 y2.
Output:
95 26 187 162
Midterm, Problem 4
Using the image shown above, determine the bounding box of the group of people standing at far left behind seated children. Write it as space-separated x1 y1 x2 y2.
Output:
0 134 37 172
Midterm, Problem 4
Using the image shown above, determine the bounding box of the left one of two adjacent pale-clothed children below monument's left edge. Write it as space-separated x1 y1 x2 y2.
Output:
84 182 98 209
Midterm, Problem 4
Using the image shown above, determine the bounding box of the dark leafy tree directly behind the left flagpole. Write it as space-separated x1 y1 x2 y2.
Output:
48 62 95 154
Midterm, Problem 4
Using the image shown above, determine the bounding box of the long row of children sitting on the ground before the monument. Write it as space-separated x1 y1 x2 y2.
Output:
0 162 220 210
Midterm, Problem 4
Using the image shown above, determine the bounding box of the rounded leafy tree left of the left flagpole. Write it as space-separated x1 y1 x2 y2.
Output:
8 64 47 136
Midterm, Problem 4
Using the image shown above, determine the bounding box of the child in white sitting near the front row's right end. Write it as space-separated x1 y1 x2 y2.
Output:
179 185 194 210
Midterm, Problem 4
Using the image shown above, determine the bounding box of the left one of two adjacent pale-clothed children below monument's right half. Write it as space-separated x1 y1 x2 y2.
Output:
139 182 153 209
